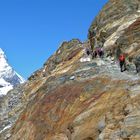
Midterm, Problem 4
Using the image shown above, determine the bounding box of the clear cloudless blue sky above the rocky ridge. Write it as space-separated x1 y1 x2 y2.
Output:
0 0 107 78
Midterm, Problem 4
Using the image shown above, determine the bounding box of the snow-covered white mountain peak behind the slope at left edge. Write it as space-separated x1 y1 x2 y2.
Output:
0 48 25 96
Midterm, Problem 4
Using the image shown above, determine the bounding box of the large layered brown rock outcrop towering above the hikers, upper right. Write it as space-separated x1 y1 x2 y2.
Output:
89 0 140 59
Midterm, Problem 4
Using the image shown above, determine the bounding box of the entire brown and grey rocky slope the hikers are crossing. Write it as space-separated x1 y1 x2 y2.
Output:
0 0 140 140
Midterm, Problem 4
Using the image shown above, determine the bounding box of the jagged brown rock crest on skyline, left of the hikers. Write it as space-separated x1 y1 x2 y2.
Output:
29 39 82 80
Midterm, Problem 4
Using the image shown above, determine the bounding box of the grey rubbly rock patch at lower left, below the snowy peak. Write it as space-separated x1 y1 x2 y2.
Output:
0 85 24 139
